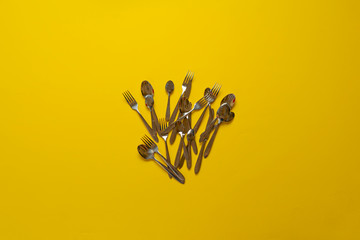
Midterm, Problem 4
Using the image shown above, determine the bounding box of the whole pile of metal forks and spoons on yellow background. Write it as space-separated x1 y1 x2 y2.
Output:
123 71 235 183
